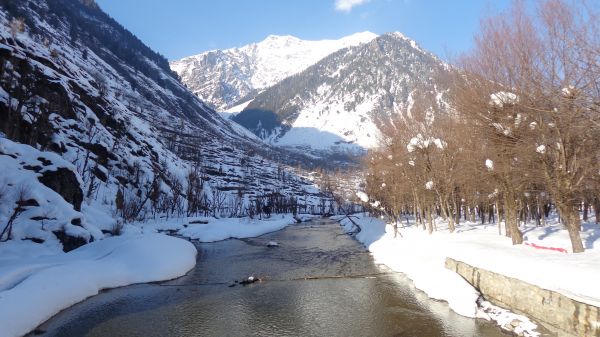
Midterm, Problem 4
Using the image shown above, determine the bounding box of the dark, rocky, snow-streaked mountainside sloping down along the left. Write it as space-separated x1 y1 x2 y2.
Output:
0 0 332 250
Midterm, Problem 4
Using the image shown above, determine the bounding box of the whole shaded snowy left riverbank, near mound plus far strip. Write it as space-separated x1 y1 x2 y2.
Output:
0 214 317 337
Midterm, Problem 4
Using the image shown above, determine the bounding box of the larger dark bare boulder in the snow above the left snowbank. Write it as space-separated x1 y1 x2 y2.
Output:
38 167 83 211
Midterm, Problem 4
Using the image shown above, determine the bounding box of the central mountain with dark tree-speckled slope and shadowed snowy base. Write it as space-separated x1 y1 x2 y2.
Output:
234 33 447 152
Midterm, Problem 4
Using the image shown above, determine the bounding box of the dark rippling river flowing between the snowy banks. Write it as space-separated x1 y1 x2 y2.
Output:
32 220 506 337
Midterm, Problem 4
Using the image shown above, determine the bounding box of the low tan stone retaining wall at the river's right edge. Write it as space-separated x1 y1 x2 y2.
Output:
446 258 600 337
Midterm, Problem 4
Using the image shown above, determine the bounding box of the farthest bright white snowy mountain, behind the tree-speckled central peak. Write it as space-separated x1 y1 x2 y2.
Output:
171 32 377 111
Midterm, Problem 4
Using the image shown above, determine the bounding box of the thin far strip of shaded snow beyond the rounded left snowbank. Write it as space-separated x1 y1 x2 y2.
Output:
132 214 318 242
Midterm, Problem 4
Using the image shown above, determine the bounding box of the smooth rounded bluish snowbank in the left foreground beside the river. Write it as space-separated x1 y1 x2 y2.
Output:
0 234 197 337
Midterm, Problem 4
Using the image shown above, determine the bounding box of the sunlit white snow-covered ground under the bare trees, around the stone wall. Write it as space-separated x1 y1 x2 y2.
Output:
341 215 600 336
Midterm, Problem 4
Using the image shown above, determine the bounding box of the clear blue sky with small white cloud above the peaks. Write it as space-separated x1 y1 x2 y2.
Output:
96 0 510 60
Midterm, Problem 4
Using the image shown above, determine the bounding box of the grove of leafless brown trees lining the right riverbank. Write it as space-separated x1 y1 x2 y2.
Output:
367 0 600 252
